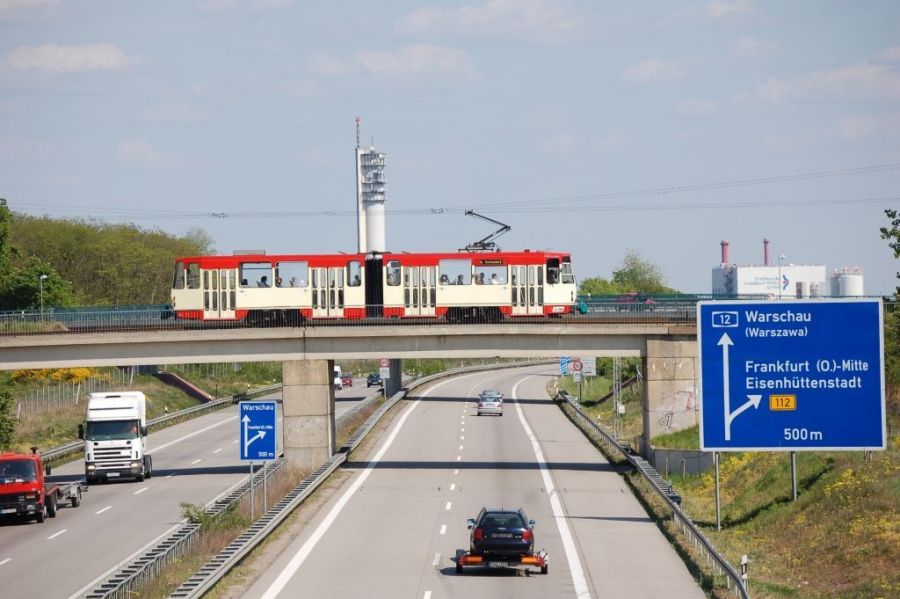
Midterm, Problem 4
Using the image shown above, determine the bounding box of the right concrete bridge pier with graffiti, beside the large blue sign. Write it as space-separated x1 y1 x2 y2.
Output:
640 336 699 455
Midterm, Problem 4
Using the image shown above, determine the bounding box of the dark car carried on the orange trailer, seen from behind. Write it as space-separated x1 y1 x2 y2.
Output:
469 508 546 573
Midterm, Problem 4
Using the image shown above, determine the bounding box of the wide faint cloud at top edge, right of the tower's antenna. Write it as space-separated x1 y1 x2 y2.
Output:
398 0 583 42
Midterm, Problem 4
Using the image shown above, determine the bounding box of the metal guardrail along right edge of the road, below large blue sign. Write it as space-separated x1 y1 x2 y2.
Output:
560 391 750 599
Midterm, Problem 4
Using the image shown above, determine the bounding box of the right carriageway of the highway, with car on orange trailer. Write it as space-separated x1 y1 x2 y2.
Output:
236 367 705 599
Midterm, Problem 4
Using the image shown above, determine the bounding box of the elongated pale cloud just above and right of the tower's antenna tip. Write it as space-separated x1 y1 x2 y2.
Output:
357 44 475 77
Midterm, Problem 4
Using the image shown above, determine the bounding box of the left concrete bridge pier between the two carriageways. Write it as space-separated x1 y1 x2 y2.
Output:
282 360 335 469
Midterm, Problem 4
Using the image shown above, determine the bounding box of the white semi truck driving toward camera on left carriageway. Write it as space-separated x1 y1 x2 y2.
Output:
78 391 153 484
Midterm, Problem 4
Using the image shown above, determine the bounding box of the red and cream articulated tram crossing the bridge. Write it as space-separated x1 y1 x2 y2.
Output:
172 250 576 325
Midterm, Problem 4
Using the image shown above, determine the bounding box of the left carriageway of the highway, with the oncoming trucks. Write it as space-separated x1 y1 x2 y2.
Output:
0 381 378 598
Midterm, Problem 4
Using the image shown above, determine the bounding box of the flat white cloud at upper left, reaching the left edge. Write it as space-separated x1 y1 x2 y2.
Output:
2 44 136 73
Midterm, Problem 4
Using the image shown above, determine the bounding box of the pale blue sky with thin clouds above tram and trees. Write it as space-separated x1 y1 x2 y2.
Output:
0 0 900 295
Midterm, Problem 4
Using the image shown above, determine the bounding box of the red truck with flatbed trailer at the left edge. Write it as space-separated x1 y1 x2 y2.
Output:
0 447 87 522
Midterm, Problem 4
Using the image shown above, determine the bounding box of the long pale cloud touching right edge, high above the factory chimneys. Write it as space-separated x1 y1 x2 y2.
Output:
736 63 900 104
